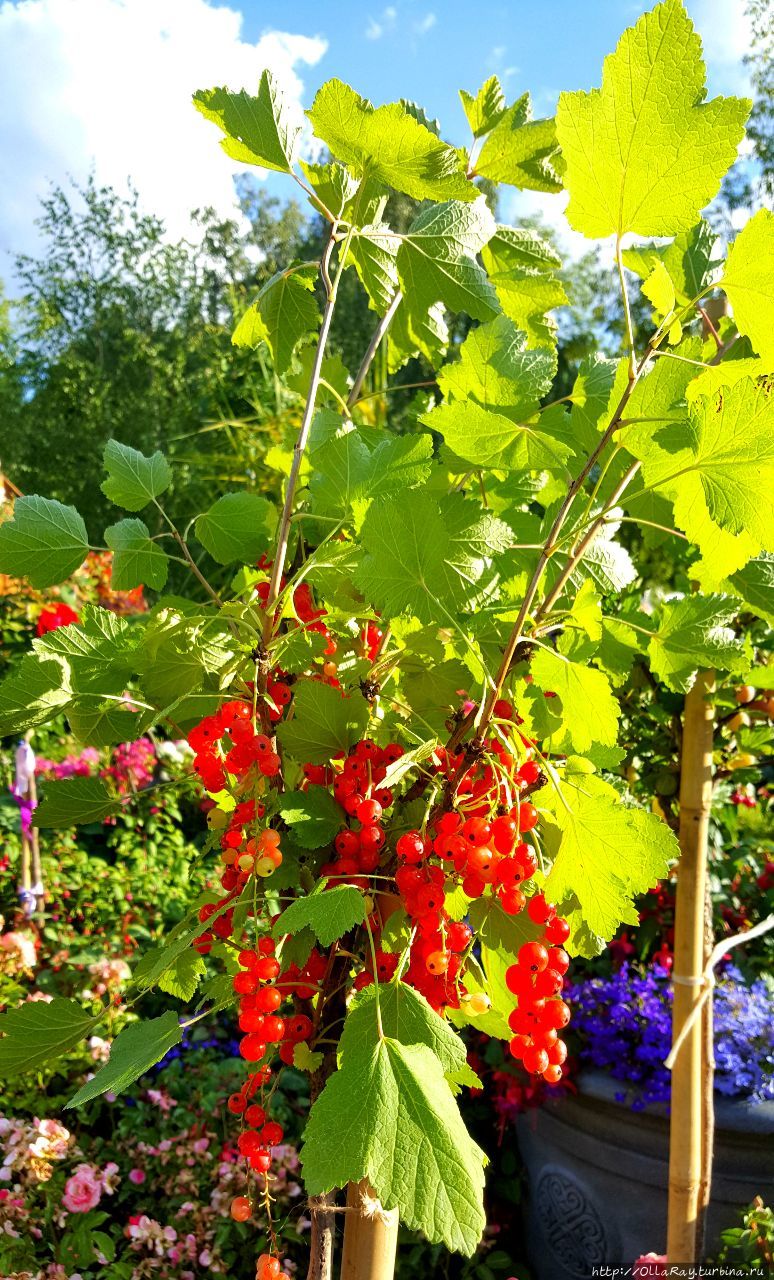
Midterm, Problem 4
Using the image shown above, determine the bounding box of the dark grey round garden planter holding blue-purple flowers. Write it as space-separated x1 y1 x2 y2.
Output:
517 1071 774 1280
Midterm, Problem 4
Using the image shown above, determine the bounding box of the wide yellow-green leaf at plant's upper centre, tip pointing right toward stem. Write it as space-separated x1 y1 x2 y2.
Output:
422 401 572 471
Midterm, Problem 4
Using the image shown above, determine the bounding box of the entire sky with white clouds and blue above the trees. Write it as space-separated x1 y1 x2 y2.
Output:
0 0 748 279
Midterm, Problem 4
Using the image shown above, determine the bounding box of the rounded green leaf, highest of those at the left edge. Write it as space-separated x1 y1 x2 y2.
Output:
0 495 88 590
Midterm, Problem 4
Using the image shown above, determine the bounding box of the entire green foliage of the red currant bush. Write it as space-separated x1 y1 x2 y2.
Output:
0 0 774 1253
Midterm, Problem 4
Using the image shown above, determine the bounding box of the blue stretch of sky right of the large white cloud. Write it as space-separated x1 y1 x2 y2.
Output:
234 0 741 124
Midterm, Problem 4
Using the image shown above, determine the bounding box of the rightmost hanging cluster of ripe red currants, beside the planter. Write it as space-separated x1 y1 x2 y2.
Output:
505 893 569 1084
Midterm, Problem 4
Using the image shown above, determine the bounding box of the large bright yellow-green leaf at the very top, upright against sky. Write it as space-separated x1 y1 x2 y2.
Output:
557 0 750 238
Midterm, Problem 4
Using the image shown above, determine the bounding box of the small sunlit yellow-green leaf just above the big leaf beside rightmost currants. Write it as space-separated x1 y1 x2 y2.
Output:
530 649 619 753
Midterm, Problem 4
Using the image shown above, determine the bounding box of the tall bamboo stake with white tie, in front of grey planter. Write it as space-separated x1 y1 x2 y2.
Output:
667 671 715 1265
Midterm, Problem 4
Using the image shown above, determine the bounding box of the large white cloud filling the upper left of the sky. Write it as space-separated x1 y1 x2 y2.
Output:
0 0 328 264
